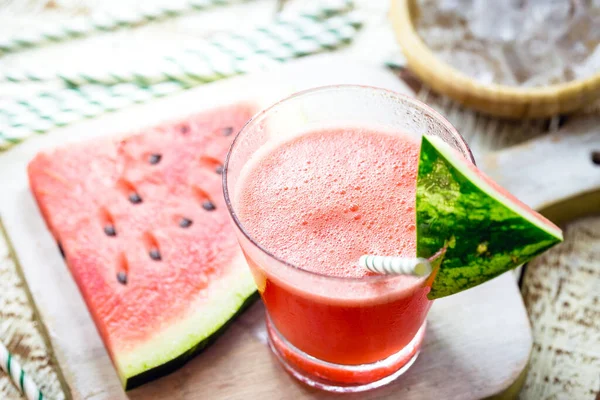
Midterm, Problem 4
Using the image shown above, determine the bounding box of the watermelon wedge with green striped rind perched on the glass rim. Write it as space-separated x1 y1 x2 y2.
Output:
416 136 563 299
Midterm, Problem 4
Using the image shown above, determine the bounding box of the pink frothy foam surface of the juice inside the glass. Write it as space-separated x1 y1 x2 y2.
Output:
236 128 419 277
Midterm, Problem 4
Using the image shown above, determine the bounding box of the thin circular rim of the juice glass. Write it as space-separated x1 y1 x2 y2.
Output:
222 84 476 283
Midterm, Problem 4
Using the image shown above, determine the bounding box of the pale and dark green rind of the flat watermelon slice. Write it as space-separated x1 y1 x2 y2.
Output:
114 256 258 390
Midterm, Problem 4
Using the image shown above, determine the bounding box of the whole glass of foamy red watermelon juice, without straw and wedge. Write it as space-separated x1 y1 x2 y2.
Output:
224 85 473 392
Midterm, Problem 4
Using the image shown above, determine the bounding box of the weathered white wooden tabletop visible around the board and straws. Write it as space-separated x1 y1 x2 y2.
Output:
0 0 600 400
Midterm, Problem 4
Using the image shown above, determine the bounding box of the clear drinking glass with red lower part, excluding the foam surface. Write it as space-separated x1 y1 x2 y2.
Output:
223 85 474 392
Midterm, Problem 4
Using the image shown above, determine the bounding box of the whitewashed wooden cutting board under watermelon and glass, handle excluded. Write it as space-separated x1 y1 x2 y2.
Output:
0 56 592 400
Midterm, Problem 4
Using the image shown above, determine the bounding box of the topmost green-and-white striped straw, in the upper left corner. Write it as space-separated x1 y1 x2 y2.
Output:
0 0 244 54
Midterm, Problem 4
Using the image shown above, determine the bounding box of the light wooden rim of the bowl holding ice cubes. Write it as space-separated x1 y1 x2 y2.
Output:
390 0 600 118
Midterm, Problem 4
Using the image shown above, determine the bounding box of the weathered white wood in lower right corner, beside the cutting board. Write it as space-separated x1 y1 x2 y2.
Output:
522 217 600 400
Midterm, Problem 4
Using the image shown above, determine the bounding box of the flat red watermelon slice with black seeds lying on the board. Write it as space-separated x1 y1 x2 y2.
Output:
28 104 256 389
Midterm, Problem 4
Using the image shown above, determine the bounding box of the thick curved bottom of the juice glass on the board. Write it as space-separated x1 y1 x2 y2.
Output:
267 314 427 393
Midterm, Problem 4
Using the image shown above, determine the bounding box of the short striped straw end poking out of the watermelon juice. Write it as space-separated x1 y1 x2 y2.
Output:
358 255 431 276
